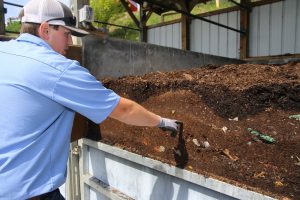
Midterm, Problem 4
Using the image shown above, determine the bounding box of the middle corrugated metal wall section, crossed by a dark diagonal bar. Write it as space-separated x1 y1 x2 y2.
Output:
191 11 240 58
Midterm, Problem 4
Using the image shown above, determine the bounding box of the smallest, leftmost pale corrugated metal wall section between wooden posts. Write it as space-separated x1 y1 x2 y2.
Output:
148 23 181 49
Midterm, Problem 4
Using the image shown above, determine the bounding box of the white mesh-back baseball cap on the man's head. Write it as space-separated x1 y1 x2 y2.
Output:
22 0 89 37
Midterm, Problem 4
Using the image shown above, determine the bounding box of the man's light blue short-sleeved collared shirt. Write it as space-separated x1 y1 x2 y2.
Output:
0 34 120 200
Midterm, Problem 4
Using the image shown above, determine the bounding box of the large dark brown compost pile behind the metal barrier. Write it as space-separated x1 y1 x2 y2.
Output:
100 62 300 199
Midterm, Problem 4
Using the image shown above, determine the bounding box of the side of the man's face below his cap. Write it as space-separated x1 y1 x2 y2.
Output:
47 26 73 55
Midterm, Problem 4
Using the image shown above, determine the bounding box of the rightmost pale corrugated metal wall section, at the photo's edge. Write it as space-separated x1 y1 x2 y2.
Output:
249 0 300 57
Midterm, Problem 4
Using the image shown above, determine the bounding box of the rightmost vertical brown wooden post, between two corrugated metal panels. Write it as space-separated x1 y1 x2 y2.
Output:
240 0 250 59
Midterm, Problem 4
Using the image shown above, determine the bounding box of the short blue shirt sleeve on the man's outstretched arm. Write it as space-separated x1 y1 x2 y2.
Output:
53 62 120 123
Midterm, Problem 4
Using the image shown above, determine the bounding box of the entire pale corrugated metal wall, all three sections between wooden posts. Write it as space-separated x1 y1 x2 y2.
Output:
148 0 300 58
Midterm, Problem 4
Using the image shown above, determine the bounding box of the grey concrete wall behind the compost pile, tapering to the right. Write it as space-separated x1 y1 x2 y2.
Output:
83 36 242 78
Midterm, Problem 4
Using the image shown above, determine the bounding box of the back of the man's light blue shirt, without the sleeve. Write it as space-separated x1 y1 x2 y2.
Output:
0 33 74 199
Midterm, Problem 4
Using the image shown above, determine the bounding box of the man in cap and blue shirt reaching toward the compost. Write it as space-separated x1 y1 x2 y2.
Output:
0 0 178 200
